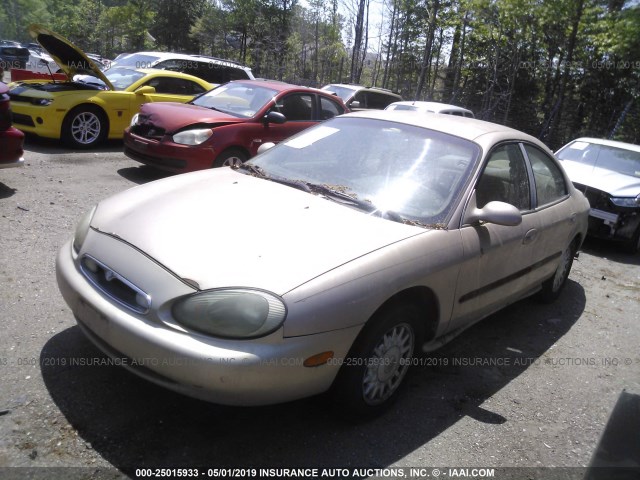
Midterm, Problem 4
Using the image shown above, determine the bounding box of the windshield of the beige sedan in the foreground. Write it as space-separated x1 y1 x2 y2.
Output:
249 117 480 226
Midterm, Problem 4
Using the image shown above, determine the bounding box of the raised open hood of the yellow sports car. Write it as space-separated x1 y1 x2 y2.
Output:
29 24 115 90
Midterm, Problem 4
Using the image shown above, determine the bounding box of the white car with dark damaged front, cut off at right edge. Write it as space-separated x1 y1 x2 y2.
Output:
556 138 640 253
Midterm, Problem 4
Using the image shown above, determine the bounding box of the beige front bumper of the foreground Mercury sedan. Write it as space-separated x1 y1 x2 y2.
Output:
56 234 361 406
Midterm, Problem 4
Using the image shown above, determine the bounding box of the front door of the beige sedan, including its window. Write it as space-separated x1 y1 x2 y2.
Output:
451 142 538 329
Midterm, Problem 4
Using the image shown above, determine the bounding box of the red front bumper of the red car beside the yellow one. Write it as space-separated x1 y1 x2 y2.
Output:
124 128 217 173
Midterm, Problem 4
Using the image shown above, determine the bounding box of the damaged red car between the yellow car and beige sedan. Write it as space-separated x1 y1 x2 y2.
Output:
124 80 348 173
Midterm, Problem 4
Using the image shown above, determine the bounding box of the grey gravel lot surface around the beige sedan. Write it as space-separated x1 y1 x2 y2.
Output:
0 137 640 479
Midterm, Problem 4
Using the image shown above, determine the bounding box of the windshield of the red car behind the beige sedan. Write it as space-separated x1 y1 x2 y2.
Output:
191 83 278 118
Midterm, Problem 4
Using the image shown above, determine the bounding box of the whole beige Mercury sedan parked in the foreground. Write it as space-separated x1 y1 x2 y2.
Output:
57 111 589 415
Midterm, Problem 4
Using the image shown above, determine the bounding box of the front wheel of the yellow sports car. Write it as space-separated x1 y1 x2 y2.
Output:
62 105 109 149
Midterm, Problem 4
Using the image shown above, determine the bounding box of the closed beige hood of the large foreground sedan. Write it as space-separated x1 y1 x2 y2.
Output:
91 168 425 295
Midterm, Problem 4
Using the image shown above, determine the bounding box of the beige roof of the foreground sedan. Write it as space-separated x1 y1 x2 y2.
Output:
342 110 553 155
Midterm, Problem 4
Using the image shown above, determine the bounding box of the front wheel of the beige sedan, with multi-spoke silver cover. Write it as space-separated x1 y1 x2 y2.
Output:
331 304 423 421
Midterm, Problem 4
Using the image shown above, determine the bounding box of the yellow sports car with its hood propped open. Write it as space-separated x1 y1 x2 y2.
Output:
9 25 213 148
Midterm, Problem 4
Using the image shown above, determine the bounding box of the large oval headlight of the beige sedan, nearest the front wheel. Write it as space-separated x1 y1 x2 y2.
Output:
172 288 287 338
